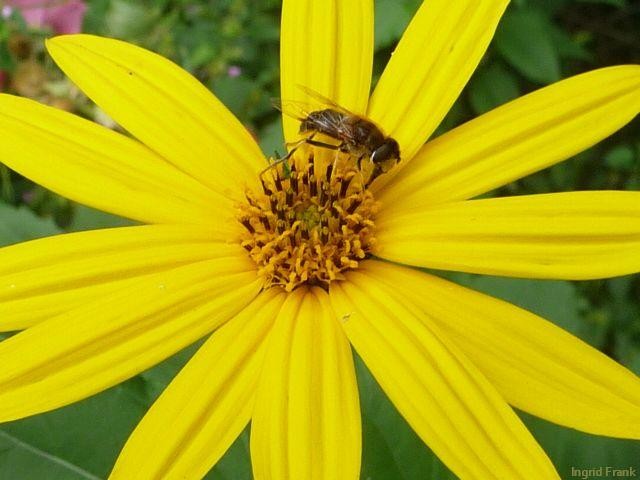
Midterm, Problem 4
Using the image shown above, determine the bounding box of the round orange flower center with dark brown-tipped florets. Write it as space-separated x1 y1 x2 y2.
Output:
238 145 377 292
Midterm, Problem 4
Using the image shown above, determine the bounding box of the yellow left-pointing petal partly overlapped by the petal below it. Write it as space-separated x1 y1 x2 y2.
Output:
0 225 239 331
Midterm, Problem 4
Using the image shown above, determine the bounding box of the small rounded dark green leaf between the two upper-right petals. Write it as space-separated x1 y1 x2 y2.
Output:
469 63 520 114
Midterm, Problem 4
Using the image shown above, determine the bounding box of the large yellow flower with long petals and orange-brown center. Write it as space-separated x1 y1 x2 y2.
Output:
0 0 640 480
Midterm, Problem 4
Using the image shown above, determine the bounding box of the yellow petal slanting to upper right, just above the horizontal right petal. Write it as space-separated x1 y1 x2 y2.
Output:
379 65 640 205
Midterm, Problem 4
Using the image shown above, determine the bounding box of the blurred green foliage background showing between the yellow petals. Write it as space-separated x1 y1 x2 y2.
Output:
0 0 640 480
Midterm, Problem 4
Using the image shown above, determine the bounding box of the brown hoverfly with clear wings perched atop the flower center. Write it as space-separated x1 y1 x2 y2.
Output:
273 86 400 183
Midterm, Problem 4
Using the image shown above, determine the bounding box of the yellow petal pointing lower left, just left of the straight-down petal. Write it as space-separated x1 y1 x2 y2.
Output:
109 289 284 480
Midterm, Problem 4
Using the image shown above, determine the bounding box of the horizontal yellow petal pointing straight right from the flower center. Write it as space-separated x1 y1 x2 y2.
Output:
376 191 640 280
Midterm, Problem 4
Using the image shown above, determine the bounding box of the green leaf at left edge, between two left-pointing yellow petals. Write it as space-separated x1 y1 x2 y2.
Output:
0 203 60 248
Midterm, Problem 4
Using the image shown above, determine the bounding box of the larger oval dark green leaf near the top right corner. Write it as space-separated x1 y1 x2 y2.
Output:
495 9 560 84
